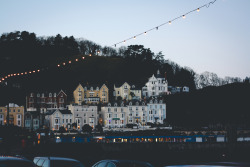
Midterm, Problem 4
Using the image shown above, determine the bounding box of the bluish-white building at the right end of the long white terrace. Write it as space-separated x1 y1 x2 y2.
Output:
147 99 166 124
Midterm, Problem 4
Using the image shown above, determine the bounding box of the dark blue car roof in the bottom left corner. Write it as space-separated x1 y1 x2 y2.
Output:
0 156 35 167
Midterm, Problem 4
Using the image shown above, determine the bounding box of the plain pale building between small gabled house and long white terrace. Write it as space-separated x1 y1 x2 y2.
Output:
68 104 98 130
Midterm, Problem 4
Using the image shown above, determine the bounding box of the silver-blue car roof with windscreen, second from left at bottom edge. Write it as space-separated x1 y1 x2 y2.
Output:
33 157 84 167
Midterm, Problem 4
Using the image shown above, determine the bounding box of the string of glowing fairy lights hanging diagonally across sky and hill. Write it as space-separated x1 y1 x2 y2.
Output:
0 0 217 83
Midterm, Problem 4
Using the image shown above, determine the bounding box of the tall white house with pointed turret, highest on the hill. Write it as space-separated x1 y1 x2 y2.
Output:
142 70 168 97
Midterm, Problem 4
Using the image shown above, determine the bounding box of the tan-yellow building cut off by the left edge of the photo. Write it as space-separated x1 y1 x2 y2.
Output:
0 103 24 127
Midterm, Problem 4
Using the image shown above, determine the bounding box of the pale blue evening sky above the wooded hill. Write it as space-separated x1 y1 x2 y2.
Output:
0 0 250 79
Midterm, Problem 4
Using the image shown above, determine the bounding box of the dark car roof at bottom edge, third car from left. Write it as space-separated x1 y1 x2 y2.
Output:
92 160 153 167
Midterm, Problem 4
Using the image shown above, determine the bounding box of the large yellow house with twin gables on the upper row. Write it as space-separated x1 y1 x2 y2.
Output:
73 84 109 105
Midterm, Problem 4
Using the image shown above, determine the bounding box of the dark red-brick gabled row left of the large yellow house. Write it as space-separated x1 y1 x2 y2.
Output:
26 90 67 113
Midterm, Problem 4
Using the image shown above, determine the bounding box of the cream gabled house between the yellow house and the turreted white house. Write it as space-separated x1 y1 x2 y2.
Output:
113 82 141 100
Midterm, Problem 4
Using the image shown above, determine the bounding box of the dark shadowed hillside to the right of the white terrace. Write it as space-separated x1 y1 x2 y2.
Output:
166 83 250 128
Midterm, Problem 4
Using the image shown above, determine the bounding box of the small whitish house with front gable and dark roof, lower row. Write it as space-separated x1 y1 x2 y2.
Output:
45 109 73 130
